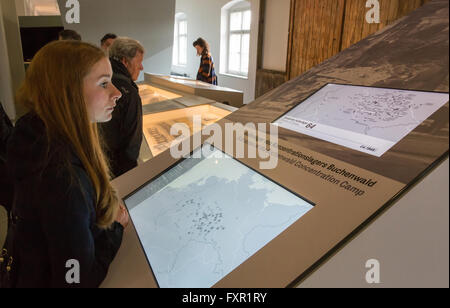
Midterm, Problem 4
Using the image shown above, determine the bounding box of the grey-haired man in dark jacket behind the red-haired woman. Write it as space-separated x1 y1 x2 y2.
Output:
100 37 145 177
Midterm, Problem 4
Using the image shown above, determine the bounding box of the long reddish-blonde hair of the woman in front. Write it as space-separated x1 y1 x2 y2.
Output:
17 41 119 228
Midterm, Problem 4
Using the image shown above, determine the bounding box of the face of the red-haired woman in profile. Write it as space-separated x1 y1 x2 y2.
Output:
83 57 122 123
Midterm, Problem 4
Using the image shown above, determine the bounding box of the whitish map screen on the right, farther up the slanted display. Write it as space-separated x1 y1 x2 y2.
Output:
274 84 449 157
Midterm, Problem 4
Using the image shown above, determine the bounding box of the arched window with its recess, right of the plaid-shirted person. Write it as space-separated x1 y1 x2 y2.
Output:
221 0 252 77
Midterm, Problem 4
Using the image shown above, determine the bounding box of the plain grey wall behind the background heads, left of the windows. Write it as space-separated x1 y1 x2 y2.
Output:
58 0 175 80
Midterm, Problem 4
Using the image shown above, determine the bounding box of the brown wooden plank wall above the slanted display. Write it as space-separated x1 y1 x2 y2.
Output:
288 0 430 79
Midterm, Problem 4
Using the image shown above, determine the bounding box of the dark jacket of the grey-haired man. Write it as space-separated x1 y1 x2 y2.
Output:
99 58 143 177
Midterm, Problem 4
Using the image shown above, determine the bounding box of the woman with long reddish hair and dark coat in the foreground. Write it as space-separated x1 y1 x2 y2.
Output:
6 40 129 288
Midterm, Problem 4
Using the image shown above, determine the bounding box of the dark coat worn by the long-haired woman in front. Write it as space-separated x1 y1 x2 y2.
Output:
7 113 123 288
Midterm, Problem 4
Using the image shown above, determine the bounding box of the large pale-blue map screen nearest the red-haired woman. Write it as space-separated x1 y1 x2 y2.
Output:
125 146 313 288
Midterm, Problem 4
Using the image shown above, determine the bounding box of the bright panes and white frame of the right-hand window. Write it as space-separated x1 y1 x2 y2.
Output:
227 7 252 76
